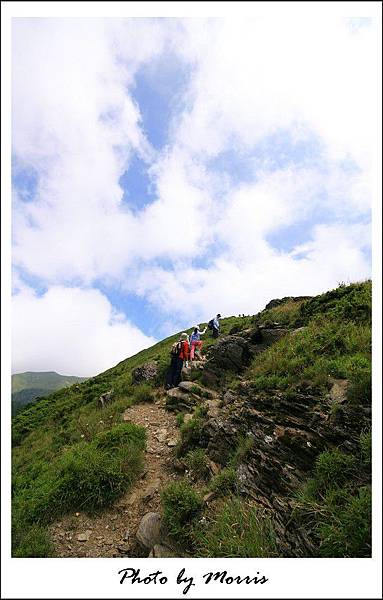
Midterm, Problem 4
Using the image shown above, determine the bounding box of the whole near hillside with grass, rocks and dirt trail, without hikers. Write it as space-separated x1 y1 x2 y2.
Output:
12 281 371 557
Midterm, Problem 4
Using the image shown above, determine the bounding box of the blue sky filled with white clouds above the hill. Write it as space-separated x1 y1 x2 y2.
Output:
12 16 378 376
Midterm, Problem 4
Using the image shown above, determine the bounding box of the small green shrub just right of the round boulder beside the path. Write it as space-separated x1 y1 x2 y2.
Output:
161 481 202 544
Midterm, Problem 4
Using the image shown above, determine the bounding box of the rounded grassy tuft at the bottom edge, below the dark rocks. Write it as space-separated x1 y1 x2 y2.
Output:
194 498 277 558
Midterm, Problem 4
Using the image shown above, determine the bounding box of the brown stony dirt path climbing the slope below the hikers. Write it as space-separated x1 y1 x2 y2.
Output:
49 400 179 558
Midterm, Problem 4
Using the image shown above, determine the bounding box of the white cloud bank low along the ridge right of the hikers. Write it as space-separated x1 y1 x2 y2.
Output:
130 225 370 326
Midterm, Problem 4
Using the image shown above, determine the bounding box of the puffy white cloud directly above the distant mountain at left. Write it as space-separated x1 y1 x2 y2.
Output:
12 286 156 376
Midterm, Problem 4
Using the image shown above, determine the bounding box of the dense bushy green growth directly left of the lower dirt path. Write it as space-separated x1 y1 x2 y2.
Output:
12 423 146 556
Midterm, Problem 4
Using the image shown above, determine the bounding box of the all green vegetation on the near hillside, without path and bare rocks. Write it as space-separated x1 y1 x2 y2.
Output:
12 281 371 558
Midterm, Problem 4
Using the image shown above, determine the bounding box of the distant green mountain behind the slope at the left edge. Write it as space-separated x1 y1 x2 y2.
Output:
12 371 87 415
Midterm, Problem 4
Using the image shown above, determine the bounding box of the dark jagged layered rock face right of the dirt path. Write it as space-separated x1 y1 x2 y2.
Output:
191 388 369 556
